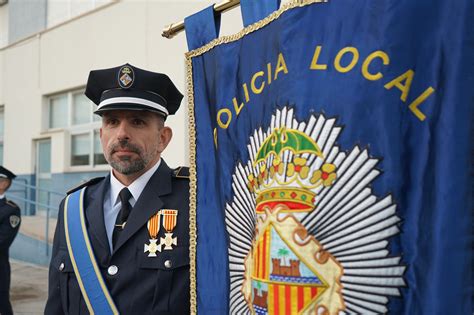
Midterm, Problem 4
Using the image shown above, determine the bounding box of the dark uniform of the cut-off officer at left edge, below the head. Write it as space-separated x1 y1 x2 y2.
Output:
0 198 20 314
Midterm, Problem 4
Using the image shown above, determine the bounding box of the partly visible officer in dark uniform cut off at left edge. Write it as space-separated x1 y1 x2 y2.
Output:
0 166 21 315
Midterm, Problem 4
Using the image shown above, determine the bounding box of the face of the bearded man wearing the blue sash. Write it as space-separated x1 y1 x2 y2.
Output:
100 110 172 178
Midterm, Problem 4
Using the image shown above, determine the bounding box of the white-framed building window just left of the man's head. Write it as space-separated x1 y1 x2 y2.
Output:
48 90 107 167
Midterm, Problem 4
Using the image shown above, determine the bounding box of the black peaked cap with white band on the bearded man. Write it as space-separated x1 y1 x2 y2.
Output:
85 63 183 118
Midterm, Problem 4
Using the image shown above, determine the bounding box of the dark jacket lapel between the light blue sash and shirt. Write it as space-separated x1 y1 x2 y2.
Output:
85 175 110 256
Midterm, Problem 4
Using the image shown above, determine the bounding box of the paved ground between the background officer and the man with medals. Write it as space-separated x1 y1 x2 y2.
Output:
10 259 48 315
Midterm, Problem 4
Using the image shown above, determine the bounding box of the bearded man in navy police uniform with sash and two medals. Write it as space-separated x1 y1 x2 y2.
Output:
45 64 190 314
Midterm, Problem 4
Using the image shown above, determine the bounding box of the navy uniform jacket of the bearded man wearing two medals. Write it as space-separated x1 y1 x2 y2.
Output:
45 160 189 315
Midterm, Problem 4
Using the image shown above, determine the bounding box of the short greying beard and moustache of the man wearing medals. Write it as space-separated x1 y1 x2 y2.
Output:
105 140 154 175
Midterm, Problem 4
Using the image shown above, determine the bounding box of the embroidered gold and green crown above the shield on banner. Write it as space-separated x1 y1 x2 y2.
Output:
247 127 336 213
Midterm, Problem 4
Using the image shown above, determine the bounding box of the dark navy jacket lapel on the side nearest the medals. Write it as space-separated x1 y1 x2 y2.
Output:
114 159 171 253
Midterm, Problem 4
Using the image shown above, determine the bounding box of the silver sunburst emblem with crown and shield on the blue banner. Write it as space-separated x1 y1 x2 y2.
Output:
226 107 406 314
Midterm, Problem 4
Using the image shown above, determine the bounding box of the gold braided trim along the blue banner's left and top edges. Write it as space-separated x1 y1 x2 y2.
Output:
185 0 326 314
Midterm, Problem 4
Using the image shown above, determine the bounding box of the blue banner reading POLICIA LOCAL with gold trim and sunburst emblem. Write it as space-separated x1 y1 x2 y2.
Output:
187 0 474 314
